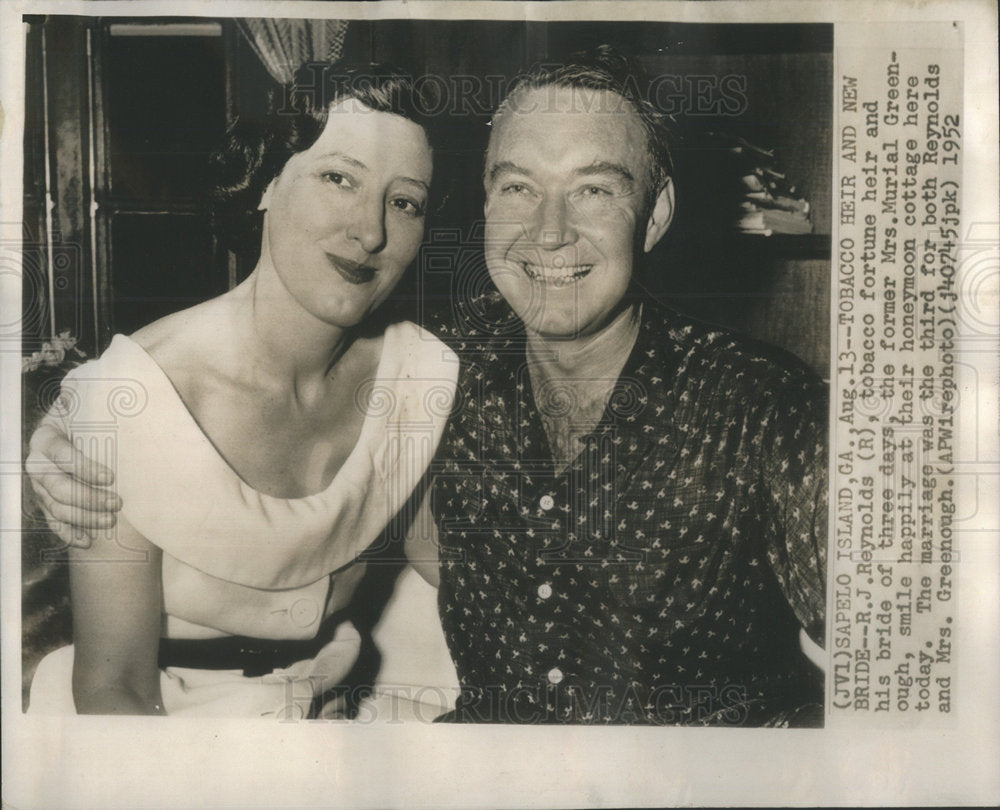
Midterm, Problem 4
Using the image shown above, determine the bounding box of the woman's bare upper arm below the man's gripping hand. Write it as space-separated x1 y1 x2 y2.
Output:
70 508 164 714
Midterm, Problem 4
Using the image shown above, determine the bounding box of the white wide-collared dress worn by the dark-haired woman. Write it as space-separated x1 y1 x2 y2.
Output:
29 322 458 719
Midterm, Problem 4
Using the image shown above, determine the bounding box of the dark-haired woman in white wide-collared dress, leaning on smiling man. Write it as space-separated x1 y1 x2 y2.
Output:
32 64 457 716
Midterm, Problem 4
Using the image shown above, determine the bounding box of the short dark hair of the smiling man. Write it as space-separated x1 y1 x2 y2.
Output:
492 45 674 201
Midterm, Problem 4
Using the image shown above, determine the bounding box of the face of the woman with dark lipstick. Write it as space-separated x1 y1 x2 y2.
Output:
260 98 433 329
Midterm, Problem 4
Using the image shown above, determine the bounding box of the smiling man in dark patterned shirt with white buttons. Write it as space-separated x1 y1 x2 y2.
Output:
29 48 826 725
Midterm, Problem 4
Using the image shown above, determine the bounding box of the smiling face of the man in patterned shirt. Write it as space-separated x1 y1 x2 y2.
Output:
485 86 672 338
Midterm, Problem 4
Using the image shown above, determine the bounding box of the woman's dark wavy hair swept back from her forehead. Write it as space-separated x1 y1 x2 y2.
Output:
209 62 443 251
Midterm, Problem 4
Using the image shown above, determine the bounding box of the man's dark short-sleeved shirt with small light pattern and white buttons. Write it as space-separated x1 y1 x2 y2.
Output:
432 296 827 725
